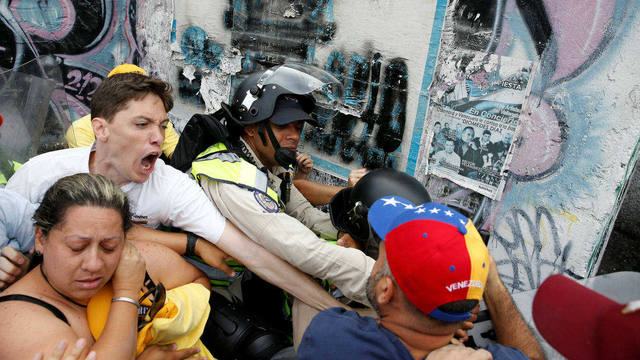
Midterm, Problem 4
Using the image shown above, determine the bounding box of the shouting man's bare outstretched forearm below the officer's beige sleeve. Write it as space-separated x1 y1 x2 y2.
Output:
216 222 344 310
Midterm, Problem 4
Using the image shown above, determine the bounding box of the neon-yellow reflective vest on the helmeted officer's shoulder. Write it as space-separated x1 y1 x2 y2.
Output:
191 143 284 211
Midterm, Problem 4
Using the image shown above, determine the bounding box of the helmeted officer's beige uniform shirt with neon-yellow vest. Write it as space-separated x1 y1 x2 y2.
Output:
192 140 375 304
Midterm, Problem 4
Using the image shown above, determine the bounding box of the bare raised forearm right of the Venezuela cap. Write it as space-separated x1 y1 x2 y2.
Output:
484 256 545 359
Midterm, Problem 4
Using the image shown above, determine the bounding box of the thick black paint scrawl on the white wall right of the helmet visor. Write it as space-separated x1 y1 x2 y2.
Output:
304 52 408 169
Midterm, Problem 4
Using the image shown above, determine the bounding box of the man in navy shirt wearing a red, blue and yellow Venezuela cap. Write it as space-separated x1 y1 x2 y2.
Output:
298 196 544 360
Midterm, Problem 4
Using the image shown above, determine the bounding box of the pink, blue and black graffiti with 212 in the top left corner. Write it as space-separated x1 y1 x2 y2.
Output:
0 0 141 118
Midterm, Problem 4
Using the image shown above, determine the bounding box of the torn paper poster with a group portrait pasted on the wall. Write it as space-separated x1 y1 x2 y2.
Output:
426 51 535 199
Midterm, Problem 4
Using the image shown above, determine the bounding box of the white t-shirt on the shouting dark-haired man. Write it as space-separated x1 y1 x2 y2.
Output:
6 147 225 244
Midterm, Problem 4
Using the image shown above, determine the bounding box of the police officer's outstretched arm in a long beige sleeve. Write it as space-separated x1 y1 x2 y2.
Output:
201 178 375 309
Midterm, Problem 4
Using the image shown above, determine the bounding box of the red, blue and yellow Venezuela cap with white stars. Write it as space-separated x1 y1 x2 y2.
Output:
368 196 490 322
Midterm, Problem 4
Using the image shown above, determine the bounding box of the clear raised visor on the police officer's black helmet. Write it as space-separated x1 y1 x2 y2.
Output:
258 63 344 113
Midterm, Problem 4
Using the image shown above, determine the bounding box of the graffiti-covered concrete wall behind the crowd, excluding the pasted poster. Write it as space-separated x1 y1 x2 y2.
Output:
0 0 640 291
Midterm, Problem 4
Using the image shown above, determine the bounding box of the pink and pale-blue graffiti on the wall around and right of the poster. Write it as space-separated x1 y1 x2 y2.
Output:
423 0 637 291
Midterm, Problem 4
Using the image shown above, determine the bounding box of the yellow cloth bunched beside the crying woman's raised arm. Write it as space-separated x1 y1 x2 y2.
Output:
136 283 215 359
